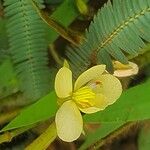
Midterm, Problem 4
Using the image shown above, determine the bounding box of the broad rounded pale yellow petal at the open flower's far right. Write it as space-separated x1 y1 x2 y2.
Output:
98 74 122 105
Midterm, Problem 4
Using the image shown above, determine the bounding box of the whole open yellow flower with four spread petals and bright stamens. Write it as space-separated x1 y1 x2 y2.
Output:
55 65 122 142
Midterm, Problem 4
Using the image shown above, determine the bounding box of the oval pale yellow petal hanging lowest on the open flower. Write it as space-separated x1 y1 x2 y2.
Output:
55 100 83 142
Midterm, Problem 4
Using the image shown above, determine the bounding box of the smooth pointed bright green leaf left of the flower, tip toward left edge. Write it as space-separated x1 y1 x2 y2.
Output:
1 92 57 132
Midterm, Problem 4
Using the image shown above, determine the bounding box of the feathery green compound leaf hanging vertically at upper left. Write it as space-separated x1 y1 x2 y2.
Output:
4 0 50 100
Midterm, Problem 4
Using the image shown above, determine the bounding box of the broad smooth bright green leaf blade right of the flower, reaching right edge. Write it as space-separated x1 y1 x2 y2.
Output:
84 80 150 123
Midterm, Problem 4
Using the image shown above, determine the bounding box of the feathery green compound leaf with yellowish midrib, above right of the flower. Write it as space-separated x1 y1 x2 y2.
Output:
67 0 150 78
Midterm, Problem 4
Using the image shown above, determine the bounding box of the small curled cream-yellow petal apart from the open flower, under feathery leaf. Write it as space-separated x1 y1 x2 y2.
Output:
114 62 139 77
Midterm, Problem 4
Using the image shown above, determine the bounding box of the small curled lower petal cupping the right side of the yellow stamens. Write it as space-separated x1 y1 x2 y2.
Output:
79 94 109 114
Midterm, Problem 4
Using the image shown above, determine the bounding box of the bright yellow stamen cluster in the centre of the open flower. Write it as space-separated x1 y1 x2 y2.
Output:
72 86 96 108
